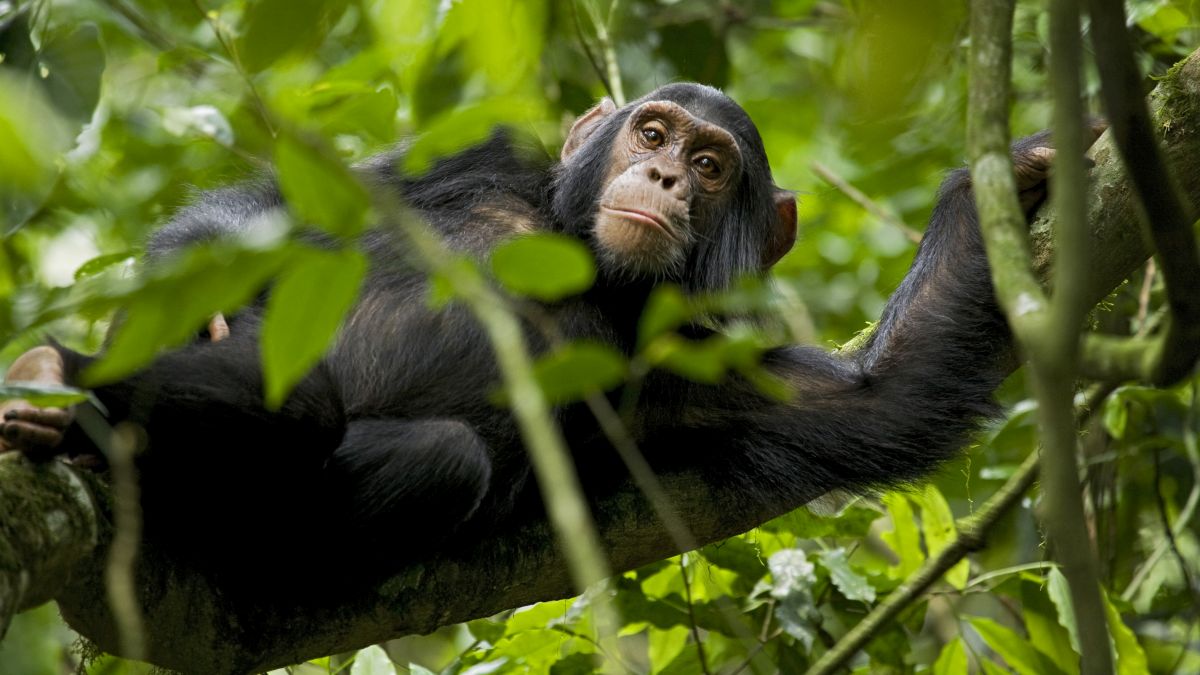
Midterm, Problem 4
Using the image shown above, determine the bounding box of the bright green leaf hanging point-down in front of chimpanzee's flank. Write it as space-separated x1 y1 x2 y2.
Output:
262 249 367 408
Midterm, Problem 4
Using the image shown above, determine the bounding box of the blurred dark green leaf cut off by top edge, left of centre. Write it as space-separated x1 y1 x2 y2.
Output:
236 0 347 72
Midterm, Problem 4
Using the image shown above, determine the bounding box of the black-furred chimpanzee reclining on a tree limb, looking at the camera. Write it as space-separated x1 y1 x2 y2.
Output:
2 84 1065 586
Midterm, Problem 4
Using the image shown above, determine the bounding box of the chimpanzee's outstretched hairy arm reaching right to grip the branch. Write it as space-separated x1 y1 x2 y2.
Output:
644 135 1075 501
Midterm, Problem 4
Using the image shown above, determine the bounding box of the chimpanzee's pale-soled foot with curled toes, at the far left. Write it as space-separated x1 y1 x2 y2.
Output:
0 346 74 459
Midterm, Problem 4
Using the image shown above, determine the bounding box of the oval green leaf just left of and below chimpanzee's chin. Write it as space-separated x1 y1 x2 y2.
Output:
492 233 595 301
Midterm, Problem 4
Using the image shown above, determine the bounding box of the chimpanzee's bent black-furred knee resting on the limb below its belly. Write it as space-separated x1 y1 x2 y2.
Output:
325 419 492 554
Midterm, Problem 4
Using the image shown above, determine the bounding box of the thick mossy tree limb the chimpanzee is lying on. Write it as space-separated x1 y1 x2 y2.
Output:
7 45 1200 673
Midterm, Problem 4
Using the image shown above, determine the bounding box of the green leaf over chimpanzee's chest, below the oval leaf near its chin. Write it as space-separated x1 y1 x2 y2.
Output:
533 342 626 404
